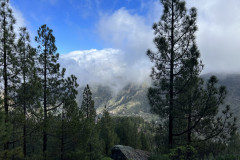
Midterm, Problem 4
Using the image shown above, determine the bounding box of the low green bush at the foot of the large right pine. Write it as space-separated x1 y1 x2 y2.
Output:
169 145 197 160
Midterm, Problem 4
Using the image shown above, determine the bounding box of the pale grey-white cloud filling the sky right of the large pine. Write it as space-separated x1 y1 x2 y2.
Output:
188 0 240 73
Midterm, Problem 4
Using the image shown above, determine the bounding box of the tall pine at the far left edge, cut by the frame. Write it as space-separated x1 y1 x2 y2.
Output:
0 0 18 150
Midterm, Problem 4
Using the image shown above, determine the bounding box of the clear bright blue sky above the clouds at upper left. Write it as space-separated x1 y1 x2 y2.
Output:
11 0 160 54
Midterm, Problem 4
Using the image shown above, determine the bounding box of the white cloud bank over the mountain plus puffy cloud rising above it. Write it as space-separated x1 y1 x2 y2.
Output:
60 8 153 90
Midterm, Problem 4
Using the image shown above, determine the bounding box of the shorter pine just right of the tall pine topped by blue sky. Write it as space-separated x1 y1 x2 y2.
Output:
57 75 78 160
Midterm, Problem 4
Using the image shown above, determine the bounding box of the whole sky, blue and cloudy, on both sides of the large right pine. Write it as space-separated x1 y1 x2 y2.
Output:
10 0 240 89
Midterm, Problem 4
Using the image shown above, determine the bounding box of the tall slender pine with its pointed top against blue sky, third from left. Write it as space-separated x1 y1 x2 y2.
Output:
35 25 66 159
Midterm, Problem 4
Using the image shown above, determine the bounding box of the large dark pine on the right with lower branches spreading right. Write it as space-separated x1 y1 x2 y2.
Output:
147 0 236 148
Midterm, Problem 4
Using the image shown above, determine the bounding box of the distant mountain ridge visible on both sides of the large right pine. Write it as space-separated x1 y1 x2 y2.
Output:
77 73 240 126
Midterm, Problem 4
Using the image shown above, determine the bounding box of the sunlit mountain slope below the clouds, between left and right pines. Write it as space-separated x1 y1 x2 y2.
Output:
78 84 158 120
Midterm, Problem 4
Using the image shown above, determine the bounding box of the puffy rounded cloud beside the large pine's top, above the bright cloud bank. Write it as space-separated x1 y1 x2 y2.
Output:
98 8 153 63
